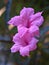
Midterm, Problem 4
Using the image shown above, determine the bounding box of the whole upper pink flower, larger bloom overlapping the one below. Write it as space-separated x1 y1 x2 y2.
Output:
8 7 44 37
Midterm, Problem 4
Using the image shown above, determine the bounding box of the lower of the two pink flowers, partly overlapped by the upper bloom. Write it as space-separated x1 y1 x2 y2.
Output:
11 33 38 56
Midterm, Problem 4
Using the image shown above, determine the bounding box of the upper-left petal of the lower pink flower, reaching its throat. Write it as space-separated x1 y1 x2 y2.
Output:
13 33 26 46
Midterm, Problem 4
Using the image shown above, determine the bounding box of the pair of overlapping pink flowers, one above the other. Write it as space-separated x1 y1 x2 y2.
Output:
8 7 44 56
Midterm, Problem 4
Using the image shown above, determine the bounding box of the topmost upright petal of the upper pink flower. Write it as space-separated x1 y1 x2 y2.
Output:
20 7 34 26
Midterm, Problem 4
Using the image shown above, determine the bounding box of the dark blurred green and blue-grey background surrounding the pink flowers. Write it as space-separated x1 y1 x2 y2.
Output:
0 0 49 65
